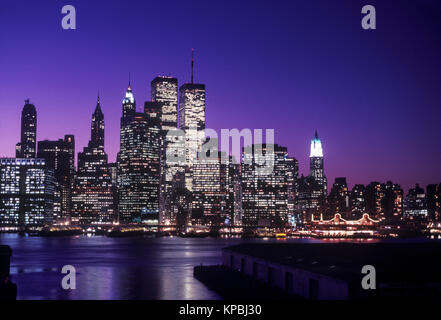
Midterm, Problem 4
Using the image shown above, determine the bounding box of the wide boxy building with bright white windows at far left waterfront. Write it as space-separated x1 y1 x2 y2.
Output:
0 158 55 228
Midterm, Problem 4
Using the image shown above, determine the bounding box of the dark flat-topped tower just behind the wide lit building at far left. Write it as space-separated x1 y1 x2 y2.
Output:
37 135 75 222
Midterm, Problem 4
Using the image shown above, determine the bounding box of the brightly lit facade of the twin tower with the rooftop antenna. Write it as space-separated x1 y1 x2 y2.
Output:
179 83 205 191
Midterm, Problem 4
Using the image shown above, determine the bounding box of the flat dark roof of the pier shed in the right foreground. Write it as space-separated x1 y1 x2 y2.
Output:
223 241 441 283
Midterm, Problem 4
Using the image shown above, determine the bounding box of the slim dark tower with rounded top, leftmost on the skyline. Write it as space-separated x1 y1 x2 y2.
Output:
16 99 37 158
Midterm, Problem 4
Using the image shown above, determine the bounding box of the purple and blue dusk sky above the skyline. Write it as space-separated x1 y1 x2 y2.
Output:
0 0 441 189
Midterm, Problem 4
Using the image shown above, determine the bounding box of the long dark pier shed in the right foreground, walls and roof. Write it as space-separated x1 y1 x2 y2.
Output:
222 241 441 300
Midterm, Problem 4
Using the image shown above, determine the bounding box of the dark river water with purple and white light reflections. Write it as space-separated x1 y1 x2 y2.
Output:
0 234 316 300
